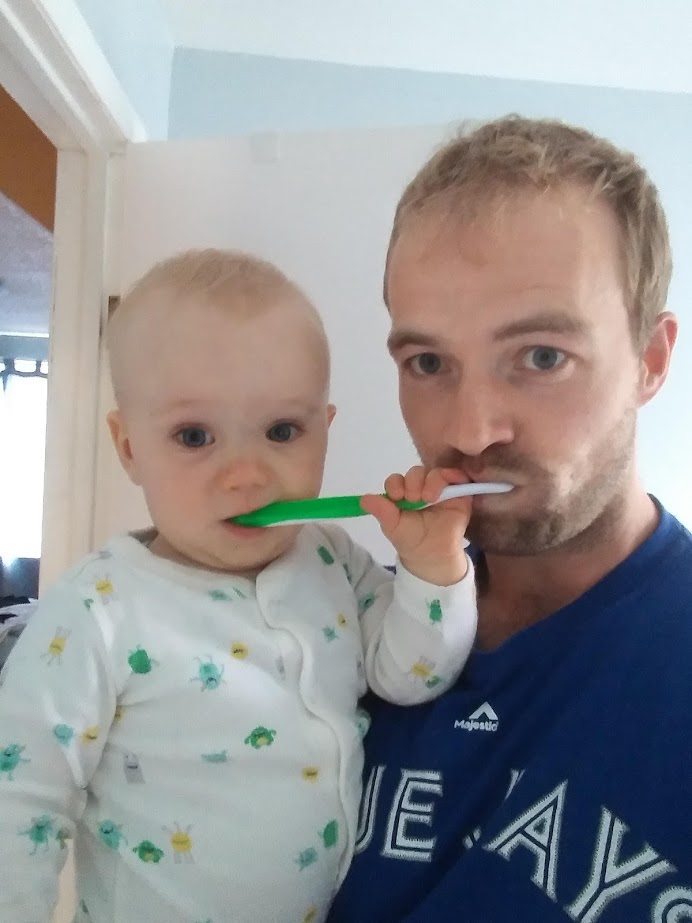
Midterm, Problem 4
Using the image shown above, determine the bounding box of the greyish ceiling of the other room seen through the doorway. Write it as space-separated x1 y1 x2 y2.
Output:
0 193 53 334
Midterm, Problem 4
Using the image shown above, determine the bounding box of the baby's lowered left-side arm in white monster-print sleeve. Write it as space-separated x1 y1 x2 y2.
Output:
0 583 115 923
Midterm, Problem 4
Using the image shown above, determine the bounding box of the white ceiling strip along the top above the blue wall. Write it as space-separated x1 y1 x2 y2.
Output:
159 0 692 93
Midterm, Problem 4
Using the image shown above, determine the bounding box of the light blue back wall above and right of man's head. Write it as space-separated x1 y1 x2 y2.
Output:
169 49 692 526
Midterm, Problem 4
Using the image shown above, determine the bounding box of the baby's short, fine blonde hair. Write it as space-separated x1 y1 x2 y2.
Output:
106 248 329 397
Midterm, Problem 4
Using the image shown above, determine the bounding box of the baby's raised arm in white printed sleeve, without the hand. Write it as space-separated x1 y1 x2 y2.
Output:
330 530 477 705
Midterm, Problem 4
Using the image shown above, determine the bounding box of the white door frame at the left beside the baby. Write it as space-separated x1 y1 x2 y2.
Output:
0 0 146 587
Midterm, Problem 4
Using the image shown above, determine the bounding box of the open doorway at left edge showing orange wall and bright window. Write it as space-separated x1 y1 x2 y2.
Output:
0 87 58 609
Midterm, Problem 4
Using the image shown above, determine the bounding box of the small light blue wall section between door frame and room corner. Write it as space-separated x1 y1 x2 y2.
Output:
77 0 173 140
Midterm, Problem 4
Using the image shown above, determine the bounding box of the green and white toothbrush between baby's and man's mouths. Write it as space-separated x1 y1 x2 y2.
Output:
229 483 512 527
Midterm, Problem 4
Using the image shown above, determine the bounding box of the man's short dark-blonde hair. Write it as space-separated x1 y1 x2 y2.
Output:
384 115 672 347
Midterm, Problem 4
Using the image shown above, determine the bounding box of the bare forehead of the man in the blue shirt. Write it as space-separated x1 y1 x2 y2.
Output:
387 195 622 323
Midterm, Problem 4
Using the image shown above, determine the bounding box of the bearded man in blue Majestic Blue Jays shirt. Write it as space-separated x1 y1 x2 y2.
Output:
330 117 692 923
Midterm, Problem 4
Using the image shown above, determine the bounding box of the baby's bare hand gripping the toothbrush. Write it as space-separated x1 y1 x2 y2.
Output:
361 465 471 586
